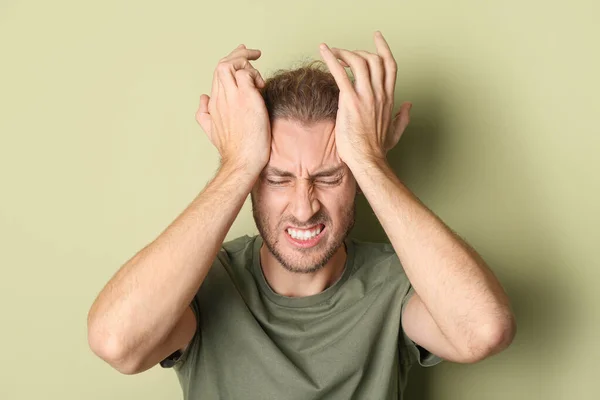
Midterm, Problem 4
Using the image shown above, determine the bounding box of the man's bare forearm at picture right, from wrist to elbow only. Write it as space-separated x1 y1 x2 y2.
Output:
353 161 512 352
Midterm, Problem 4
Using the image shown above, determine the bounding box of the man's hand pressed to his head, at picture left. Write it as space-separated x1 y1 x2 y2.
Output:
196 44 271 175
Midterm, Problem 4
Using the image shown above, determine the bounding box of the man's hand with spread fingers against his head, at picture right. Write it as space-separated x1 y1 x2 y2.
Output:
320 31 412 168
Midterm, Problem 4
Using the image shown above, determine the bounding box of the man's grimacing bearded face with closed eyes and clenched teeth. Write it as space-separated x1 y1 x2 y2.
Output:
251 119 356 273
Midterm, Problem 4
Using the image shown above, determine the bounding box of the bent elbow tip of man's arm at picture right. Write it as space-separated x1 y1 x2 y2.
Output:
463 313 517 363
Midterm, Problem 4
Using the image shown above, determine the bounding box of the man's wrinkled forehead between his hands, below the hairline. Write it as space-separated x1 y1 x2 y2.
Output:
268 119 341 173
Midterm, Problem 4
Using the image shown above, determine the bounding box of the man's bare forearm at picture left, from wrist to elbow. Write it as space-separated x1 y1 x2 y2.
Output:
88 163 256 358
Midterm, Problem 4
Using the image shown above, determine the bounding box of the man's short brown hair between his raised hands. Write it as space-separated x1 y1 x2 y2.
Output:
260 60 350 125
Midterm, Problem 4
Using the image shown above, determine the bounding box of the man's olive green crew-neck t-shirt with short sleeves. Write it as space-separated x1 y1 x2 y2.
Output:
168 235 441 400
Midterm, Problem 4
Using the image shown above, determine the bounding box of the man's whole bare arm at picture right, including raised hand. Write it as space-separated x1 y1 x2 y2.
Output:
321 32 515 362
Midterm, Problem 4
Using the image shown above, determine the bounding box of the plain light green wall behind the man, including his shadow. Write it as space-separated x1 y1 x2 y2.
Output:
0 0 600 400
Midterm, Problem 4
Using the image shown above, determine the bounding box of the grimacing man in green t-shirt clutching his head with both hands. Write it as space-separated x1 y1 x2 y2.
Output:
88 32 515 399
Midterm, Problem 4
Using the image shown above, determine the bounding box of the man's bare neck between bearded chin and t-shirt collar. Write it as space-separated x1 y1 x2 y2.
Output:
260 243 347 297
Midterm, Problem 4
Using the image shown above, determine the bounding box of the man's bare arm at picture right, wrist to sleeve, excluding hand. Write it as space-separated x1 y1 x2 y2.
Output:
355 161 515 363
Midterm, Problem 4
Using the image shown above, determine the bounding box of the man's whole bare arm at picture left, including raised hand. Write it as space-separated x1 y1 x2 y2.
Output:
88 45 271 374
